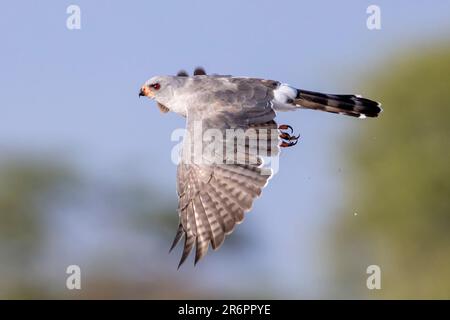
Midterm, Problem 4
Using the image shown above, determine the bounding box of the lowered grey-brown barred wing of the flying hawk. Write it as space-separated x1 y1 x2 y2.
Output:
171 78 279 267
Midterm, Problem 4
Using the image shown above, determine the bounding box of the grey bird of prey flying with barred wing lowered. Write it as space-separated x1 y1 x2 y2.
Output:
139 68 382 268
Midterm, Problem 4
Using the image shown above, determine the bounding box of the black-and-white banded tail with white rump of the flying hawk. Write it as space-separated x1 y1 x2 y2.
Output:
274 84 383 118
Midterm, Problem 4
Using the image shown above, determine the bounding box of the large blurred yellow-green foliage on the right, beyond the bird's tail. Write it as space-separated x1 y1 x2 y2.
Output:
335 46 450 299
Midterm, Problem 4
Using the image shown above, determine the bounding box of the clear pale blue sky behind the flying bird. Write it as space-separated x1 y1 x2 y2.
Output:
0 0 450 297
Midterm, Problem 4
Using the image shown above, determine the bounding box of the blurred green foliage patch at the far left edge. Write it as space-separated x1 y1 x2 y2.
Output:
0 155 75 298
